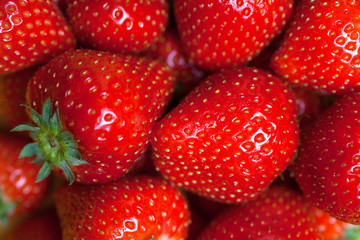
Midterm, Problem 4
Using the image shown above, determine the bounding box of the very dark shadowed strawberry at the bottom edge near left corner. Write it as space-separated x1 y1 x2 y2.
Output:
5 209 62 240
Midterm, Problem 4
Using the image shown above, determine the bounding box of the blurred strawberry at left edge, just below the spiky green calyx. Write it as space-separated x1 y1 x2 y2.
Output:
0 133 49 226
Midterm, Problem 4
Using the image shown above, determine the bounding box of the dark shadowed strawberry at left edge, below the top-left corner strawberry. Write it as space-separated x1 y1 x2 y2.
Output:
0 68 37 128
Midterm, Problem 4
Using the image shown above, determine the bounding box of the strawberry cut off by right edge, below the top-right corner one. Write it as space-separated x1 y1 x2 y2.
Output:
291 93 360 224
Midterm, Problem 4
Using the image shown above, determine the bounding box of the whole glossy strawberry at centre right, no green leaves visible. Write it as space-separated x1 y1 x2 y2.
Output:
151 67 298 203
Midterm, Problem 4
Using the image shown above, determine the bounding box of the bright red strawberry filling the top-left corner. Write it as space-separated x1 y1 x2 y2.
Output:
0 0 75 74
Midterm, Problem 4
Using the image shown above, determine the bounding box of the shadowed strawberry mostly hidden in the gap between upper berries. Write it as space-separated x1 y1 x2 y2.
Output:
145 29 205 98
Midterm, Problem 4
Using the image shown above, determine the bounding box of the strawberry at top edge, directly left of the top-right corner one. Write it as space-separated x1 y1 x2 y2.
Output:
174 0 293 70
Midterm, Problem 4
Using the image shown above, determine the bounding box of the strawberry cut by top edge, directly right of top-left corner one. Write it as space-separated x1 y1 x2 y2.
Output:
66 0 169 53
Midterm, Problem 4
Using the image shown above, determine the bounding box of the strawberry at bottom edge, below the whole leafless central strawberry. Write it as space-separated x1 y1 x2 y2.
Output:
198 187 324 240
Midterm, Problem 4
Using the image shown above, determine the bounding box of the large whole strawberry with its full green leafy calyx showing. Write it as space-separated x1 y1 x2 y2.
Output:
14 49 175 183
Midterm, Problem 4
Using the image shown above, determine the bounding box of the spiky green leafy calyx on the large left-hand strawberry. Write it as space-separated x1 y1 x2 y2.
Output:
11 98 88 184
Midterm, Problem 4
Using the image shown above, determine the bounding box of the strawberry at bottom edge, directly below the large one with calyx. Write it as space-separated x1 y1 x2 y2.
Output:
54 175 190 240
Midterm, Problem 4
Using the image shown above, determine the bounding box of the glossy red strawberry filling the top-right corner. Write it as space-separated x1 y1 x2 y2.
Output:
271 0 360 95
